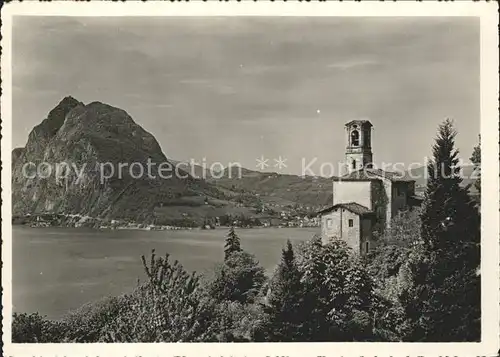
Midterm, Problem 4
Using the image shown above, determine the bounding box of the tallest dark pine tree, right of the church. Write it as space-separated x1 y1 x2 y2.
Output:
402 120 481 342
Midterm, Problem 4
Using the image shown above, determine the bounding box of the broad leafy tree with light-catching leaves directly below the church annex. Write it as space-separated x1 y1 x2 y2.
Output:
297 237 373 341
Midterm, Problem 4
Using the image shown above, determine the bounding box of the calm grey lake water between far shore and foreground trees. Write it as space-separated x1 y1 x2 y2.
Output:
12 226 319 318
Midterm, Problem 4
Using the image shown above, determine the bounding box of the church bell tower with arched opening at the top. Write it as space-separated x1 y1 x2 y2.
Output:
345 120 373 172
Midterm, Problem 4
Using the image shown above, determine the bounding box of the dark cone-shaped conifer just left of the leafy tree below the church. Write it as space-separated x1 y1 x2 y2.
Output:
260 241 309 342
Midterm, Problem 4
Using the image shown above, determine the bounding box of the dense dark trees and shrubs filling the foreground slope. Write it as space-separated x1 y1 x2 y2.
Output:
12 121 481 342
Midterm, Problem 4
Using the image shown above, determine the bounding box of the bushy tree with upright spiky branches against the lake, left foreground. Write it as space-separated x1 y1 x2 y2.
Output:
100 250 218 342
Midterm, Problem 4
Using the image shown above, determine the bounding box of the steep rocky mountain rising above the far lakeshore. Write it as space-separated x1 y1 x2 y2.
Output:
12 97 218 221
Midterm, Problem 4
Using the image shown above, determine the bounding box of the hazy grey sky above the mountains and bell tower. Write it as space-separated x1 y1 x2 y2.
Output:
12 16 480 174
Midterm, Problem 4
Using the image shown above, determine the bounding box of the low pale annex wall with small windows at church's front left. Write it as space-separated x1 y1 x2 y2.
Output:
321 208 361 253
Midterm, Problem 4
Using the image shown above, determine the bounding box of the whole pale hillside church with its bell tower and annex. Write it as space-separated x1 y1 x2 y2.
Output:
319 120 421 255
